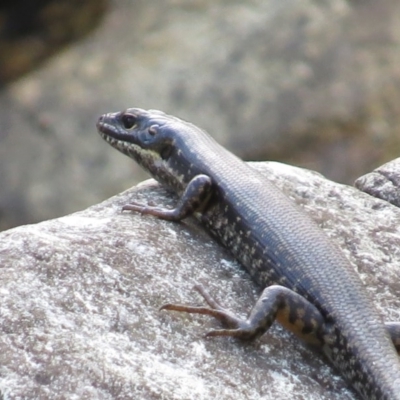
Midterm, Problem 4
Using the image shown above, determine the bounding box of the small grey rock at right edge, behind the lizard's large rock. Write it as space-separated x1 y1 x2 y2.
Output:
354 158 400 207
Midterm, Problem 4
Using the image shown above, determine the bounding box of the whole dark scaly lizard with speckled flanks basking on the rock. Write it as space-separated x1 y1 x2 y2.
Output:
97 108 400 400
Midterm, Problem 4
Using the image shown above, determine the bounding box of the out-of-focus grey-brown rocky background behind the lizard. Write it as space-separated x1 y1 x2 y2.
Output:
0 0 400 229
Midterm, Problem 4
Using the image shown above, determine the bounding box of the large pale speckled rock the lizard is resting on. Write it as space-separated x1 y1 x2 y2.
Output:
0 163 400 400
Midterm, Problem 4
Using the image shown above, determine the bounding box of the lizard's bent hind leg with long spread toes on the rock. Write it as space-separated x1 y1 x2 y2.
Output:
161 285 324 346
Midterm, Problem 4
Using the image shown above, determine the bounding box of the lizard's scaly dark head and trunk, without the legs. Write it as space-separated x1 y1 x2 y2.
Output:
98 109 400 400
